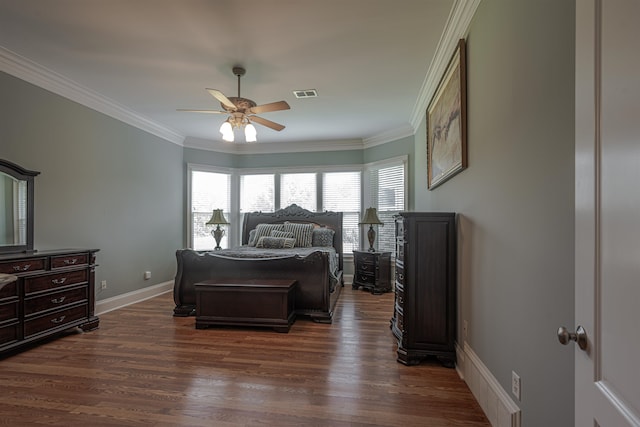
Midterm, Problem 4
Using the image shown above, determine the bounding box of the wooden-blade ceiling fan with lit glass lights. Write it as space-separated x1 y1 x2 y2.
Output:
178 67 291 142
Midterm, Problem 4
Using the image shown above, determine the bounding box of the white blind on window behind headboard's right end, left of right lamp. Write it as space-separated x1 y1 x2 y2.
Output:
322 171 362 254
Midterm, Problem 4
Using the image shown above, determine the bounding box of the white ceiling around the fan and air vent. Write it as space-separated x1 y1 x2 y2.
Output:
0 0 461 150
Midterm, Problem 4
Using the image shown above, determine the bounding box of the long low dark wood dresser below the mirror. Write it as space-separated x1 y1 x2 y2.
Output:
0 249 99 354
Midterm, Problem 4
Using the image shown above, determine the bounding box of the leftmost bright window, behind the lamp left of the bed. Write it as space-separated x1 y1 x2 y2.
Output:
190 170 231 250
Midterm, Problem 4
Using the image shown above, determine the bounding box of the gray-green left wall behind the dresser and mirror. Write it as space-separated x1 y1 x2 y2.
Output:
0 73 184 300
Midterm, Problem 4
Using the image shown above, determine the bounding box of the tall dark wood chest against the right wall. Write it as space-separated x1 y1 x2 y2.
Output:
391 212 457 367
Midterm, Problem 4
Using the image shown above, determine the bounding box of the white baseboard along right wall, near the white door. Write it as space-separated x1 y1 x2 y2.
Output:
456 342 520 427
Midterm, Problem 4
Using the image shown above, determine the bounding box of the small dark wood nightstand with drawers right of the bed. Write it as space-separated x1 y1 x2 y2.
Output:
351 251 391 294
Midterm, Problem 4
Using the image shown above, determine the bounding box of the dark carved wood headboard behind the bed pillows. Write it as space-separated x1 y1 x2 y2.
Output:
242 205 343 270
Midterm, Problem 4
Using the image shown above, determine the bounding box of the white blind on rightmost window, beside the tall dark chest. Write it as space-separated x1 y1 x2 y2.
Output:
370 162 405 252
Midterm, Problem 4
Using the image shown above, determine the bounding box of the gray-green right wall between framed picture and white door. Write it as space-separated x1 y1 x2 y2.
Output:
415 0 575 427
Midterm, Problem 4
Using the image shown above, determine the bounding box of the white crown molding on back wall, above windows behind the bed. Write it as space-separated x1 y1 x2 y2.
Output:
183 137 364 154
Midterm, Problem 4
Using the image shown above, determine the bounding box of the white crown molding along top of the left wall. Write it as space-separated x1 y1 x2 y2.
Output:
0 46 185 146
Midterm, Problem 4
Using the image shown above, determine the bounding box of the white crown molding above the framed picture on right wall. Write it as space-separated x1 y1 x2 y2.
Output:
411 0 481 133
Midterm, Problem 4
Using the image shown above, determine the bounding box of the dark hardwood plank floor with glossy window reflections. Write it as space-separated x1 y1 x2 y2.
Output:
0 286 490 427
